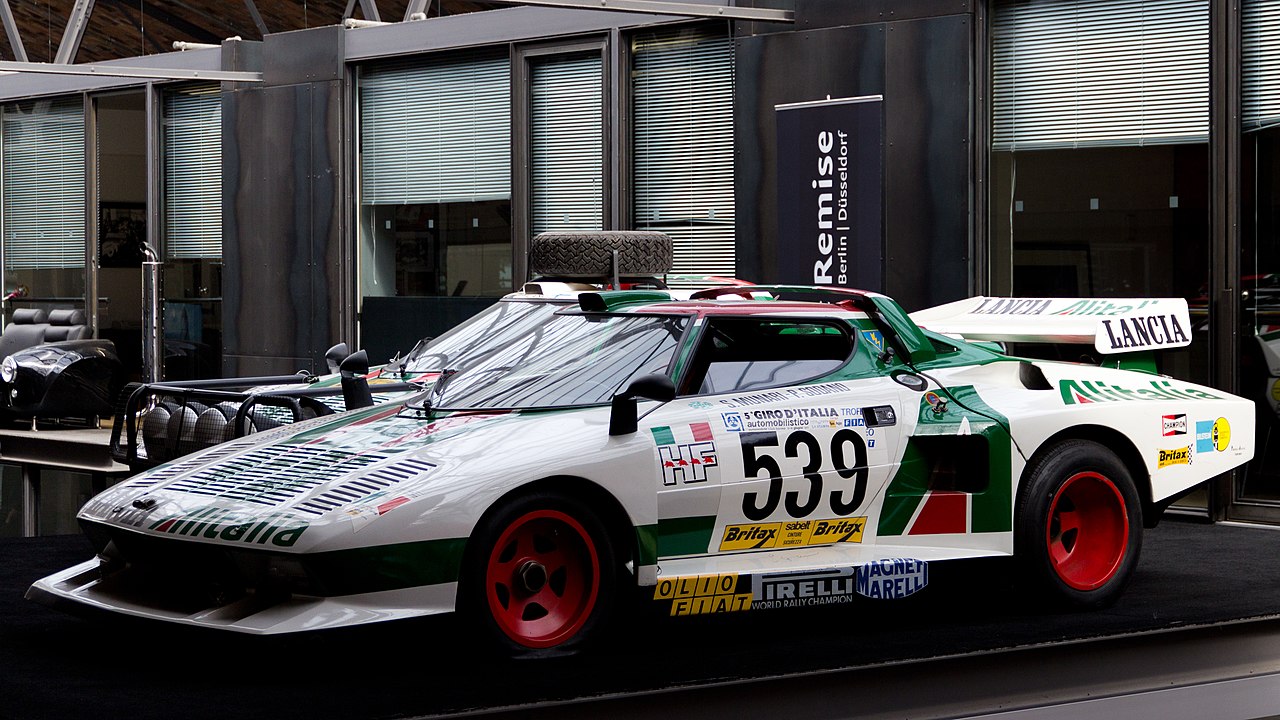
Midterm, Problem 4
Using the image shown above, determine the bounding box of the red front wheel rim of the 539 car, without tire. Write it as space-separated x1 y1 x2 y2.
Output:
485 510 600 648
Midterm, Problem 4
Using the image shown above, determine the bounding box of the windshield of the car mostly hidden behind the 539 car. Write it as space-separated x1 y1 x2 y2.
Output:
402 300 571 373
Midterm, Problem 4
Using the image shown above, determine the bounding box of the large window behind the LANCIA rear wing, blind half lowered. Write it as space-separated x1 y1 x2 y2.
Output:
989 0 1212 509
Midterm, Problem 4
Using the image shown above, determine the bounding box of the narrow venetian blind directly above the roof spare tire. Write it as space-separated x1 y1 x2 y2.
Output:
529 54 604 234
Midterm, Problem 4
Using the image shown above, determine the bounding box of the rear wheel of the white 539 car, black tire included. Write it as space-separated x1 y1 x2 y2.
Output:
1014 439 1142 609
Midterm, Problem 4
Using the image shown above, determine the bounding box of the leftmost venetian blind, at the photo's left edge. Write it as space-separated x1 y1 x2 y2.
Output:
0 97 84 270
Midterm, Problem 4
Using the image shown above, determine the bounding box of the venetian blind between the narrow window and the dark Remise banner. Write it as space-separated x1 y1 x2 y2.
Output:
631 23 735 280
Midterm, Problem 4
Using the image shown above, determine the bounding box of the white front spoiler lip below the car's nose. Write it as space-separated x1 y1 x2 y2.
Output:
26 559 458 635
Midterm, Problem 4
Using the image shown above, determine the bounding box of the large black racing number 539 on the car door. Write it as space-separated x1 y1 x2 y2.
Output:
739 428 867 521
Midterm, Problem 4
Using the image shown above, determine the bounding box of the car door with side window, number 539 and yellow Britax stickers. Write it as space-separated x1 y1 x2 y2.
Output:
682 318 905 553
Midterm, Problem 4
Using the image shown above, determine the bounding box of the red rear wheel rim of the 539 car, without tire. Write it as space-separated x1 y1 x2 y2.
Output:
1044 473 1129 591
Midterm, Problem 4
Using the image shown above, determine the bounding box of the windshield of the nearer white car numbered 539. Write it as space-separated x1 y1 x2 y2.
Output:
429 314 689 410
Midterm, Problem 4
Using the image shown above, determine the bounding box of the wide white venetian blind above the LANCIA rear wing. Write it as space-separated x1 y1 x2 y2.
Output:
992 0 1208 150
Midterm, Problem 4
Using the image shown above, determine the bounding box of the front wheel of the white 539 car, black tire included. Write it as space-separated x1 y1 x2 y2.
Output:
458 492 620 657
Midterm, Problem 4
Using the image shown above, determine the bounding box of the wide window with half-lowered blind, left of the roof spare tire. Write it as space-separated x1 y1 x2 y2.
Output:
358 50 512 297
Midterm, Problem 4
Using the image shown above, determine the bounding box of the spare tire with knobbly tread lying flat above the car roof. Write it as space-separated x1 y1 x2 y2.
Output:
529 231 672 278
